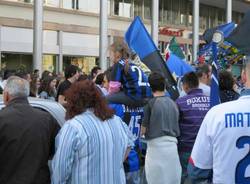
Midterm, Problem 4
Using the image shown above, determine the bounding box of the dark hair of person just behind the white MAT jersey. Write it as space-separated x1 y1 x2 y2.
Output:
219 70 235 90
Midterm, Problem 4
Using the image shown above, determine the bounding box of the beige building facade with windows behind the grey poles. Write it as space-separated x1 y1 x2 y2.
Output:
0 0 250 73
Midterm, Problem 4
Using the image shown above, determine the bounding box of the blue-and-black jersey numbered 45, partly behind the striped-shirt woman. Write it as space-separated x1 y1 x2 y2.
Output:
110 104 143 172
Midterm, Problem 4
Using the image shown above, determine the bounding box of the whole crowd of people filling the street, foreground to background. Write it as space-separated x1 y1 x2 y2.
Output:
0 40 250 184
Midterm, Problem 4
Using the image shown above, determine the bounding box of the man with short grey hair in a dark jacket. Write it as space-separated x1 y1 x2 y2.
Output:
0 77 59 184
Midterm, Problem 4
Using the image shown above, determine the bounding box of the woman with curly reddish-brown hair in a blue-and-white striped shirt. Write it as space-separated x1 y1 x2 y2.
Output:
52 80 133 184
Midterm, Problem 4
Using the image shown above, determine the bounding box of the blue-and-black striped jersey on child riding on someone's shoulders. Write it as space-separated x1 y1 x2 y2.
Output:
111 60 151 100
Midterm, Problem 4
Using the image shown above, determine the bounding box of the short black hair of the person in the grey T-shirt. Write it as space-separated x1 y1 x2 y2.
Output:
148 72 166 92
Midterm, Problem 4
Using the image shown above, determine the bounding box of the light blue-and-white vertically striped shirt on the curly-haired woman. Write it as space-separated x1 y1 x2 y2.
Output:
52 110 133 184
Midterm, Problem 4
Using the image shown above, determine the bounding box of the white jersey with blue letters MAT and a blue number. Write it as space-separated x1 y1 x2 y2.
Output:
191 96 250 184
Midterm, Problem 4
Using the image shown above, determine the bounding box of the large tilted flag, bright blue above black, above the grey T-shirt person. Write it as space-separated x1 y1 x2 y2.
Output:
125 17 179 99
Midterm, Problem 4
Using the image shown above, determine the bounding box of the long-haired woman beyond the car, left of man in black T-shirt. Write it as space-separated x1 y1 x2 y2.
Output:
38 76 57 101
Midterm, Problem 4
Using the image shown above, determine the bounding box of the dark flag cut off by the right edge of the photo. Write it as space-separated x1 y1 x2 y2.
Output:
226 11 250 55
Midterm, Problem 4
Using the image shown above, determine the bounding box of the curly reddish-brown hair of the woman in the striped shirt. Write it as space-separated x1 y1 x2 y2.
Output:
65 80 114 121
